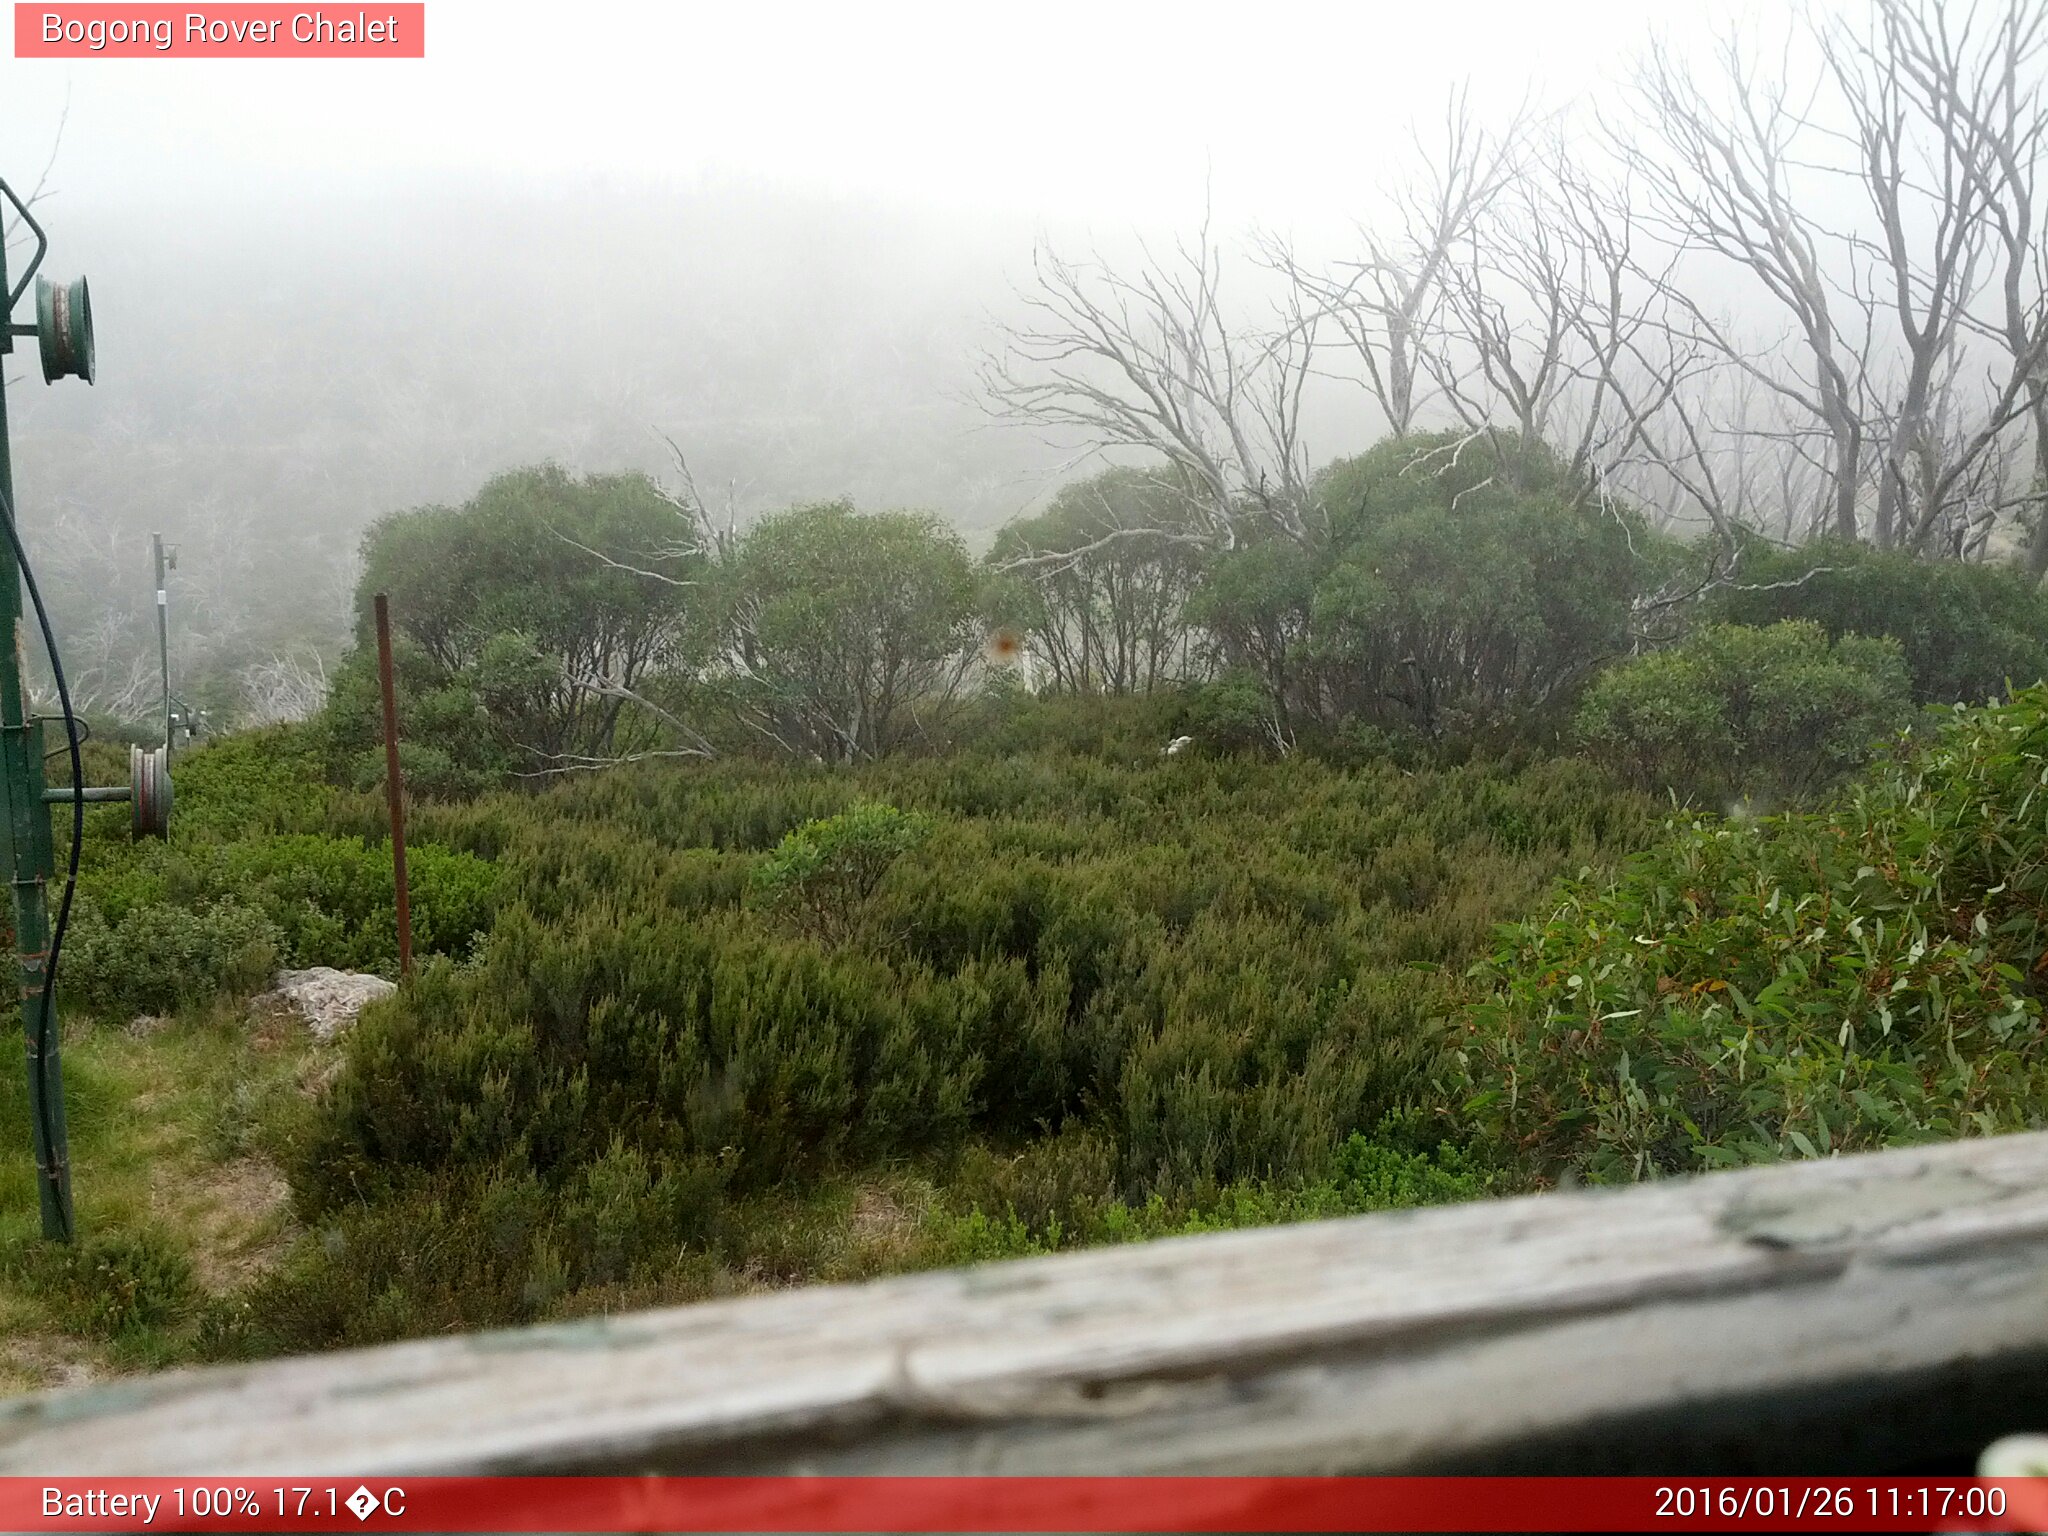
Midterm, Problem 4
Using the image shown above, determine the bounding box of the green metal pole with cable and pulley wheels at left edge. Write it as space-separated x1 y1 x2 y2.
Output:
0 228 72 1243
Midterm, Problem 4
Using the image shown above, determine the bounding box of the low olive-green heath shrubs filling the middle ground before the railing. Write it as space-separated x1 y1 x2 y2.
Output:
258 700 1651 1346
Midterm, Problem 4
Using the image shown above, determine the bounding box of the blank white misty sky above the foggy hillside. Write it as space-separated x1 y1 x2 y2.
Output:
12 0 1744 227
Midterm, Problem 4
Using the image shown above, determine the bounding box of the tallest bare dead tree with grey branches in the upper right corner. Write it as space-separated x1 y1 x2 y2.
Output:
1608 0 2048 571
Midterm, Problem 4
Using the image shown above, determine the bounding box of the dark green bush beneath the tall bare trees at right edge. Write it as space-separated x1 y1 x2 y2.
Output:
1708 539 2048 705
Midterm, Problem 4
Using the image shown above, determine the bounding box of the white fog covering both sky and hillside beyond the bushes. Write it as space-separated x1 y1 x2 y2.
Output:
0 0 1867 720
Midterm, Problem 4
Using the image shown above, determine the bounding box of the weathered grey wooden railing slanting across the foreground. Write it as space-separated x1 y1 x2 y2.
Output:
0 1135 2048 1475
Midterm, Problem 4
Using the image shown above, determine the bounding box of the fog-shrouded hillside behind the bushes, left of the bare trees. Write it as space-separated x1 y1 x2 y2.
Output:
14 188 1081 720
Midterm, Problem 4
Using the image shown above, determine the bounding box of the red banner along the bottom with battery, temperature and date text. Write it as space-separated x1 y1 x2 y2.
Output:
0 1477 2048 1532
